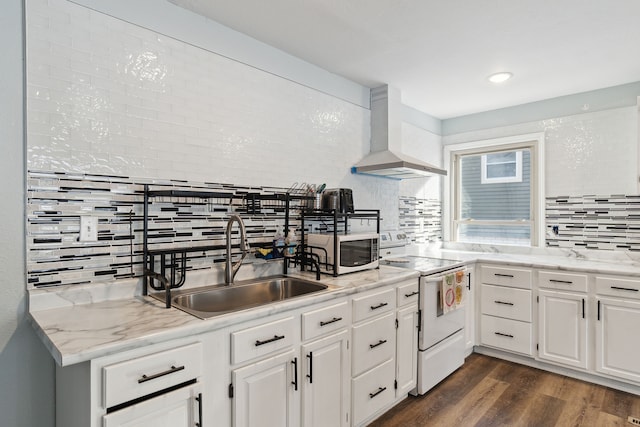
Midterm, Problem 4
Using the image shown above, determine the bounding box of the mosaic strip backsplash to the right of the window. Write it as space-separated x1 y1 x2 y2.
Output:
546 195 640 251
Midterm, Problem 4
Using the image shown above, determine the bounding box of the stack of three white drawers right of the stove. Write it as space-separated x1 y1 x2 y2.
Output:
480 265 533 356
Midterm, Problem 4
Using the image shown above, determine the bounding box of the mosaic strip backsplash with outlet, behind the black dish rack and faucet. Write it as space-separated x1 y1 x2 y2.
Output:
27 171 310 288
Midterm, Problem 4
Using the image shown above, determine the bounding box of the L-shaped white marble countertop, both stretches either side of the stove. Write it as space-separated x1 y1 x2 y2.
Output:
30 246 640 366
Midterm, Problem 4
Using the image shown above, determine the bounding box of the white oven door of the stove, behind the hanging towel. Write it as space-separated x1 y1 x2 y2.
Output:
418 269 469 351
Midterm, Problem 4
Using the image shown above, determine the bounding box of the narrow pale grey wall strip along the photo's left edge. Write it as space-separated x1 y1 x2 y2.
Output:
0 0 55 427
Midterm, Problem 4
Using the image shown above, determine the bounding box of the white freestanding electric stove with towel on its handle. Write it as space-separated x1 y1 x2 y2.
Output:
380 232 470 394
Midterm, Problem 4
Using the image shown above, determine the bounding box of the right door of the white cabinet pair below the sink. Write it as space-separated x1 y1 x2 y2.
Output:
302 330 351 427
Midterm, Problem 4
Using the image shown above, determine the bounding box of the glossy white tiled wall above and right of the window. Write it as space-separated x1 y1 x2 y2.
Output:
443 106 638 197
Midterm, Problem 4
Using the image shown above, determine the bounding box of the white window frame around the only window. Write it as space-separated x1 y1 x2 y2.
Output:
443 133 545 247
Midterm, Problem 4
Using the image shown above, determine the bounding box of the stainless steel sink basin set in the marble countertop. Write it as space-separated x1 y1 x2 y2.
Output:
172 277 328 318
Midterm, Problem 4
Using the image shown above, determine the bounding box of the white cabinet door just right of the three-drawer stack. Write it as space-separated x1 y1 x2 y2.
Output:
538 290 587 369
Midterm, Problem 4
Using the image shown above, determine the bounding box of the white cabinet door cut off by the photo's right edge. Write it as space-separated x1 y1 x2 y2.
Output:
596 298 640 382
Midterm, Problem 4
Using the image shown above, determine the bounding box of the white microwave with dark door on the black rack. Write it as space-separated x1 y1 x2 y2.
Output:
307 233 380 274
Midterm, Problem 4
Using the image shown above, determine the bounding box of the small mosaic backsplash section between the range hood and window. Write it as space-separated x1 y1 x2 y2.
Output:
398 196 442 243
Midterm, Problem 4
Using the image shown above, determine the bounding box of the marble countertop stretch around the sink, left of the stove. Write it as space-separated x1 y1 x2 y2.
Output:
30 266 418 366
